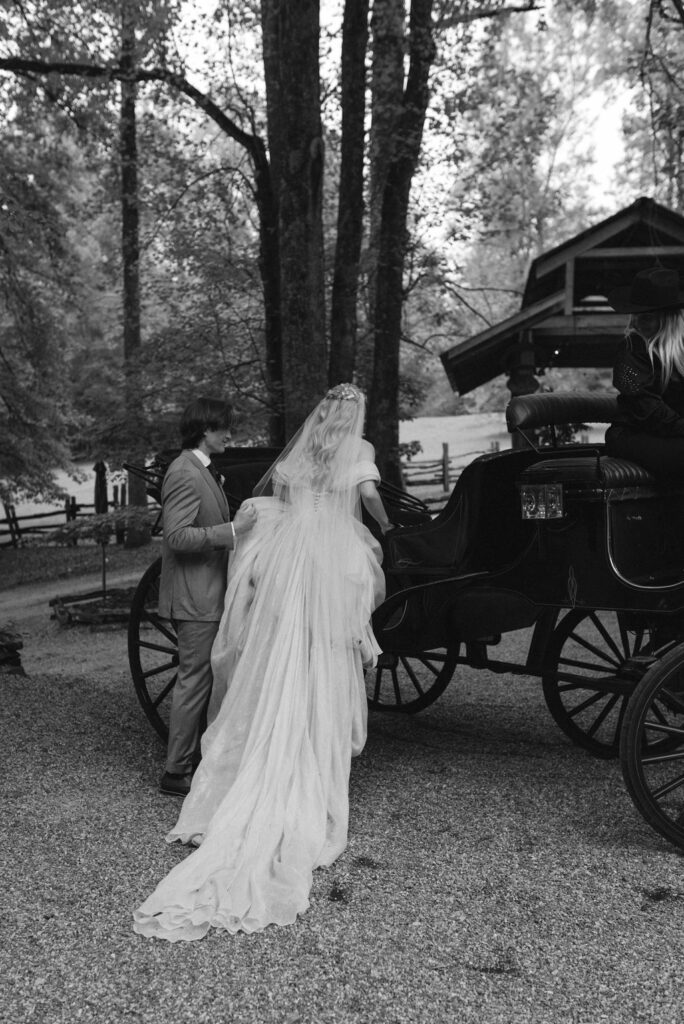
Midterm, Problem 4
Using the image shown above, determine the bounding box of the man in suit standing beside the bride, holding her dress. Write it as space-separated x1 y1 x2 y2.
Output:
159 398 256 797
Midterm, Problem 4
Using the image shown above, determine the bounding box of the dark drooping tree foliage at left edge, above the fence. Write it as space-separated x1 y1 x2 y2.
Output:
0 105 84 501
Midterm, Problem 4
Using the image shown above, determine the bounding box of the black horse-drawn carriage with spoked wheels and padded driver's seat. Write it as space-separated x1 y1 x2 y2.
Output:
129 392 684 847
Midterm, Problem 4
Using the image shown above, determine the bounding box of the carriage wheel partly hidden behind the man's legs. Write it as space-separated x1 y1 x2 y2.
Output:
128 558 178 740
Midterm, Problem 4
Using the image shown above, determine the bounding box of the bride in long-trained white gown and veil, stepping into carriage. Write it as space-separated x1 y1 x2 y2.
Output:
134 384 390 942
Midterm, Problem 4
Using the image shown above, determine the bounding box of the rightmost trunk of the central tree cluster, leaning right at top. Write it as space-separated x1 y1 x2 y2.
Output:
368 0 435 485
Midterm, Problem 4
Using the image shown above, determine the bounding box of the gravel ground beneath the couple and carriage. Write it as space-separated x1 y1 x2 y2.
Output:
0 580 684 1024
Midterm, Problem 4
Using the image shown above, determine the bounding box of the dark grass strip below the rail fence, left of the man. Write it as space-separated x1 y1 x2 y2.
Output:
0 541 161 591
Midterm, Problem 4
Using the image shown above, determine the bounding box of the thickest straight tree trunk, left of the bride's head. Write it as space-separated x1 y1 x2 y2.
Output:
261 0 328 436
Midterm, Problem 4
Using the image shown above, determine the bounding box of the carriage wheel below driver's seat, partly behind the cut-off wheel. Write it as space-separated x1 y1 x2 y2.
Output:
542 608 652 758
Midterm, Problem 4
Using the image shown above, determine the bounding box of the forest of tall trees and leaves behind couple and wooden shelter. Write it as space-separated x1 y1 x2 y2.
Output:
0 0 684 499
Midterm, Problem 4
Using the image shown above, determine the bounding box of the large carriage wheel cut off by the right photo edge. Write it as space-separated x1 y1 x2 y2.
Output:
619 645 684 847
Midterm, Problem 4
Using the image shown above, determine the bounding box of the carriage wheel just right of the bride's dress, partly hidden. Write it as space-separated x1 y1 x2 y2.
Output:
366 644 459 715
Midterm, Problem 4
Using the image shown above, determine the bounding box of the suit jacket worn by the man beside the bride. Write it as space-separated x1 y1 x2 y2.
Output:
159 450 231 622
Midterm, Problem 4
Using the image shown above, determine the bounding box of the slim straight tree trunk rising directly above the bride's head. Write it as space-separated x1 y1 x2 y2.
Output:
329 0 369 384
